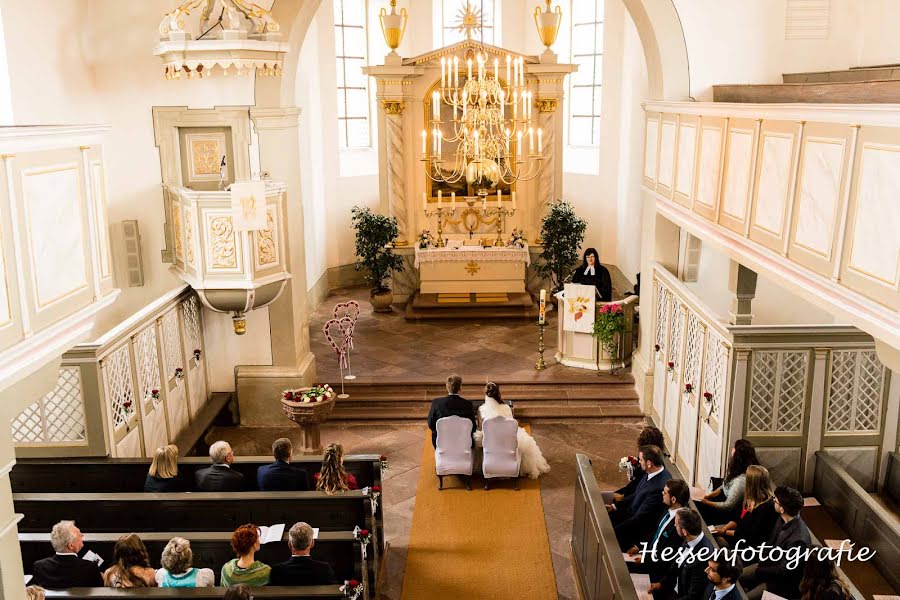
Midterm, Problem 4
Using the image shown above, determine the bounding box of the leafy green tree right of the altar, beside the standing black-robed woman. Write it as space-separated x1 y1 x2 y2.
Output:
534 200 587 293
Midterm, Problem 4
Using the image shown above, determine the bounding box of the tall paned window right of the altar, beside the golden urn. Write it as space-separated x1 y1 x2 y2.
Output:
568 0 604 147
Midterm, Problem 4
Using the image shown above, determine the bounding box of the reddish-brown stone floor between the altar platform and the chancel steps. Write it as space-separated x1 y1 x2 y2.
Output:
309 288 612 381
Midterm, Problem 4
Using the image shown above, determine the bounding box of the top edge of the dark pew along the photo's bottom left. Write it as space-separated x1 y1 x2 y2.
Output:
38 585 346 600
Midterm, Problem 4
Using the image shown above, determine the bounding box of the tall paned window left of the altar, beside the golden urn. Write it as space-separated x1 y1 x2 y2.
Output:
334 0 372 149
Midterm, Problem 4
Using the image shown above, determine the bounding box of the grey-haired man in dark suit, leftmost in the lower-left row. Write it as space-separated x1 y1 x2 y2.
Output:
31 521 103 590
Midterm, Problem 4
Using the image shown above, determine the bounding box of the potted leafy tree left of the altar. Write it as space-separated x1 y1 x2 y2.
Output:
351 206 403 312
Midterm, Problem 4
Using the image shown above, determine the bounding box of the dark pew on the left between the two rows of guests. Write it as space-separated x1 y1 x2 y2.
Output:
13 490 375 533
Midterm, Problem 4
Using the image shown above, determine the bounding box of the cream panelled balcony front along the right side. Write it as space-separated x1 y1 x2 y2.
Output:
643 102 900 360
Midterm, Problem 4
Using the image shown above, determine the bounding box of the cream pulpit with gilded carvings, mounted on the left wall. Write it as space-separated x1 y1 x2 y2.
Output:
163 180 291 334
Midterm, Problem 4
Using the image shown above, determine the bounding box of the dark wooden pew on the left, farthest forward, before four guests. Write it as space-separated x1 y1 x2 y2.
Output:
9 454 381 493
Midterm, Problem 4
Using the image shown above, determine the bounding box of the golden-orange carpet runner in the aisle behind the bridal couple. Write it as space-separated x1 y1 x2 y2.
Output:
403 431 557 600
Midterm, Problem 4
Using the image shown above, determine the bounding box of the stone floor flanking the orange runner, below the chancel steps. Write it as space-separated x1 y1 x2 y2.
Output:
207 422 642 600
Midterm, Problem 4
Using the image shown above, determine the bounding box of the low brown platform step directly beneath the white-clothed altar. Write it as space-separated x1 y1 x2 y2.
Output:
405 292 538 321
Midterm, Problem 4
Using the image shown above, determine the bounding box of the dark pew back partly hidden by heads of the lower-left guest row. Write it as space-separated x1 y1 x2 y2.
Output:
19 531 362 585
